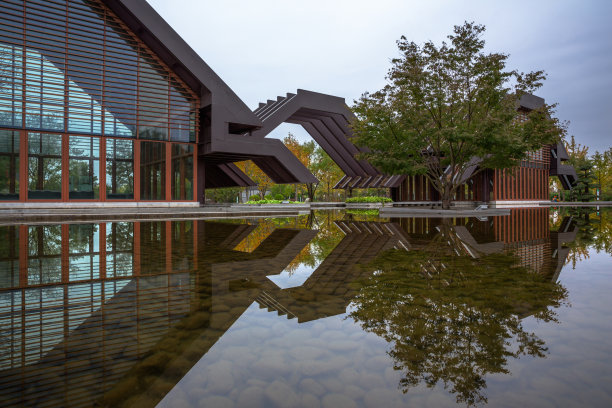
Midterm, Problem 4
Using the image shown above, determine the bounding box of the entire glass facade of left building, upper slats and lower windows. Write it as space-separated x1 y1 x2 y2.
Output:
0 0 199 201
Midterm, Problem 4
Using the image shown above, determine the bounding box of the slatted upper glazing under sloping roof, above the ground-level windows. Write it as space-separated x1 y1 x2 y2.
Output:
0 0 199 142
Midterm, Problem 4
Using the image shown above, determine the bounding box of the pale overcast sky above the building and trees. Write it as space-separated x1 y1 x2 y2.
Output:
148 0 612 153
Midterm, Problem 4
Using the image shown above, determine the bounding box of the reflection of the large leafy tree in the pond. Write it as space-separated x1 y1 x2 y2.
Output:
349 239 567 405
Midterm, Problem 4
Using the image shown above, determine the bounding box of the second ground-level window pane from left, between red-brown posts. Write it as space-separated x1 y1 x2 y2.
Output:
28 133 62 200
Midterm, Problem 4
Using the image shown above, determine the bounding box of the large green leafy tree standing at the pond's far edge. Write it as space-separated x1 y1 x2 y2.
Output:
353 22 564 209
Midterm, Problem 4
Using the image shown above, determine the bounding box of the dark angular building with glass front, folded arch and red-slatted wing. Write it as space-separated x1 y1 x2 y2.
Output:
0 0 571 206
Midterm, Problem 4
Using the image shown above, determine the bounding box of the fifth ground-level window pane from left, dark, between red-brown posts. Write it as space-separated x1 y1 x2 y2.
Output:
140 142 166 200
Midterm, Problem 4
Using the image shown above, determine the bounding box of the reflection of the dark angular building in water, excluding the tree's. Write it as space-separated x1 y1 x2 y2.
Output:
0 209 575 406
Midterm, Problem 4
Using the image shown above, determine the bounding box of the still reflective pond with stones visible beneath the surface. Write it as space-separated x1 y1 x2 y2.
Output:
0 208 612 408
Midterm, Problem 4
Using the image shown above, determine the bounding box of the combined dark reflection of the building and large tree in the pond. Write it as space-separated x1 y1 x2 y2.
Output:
0 209 576 406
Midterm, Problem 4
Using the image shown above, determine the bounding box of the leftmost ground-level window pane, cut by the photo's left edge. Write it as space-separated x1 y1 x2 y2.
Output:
0 130 19 200
